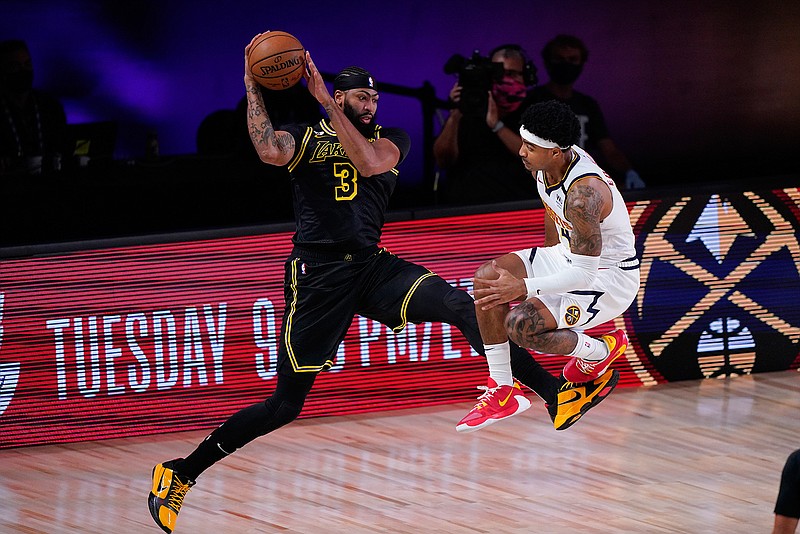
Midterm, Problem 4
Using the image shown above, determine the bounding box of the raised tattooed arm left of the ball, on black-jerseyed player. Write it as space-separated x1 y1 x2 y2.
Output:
244 34 295 165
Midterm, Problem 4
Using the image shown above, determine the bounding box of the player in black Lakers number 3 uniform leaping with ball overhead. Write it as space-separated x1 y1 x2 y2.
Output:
148 31 620 532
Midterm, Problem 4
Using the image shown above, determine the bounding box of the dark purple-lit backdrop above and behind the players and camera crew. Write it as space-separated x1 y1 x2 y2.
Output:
0 0 800 188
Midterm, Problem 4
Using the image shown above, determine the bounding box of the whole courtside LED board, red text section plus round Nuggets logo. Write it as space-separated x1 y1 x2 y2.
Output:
0 190 800 448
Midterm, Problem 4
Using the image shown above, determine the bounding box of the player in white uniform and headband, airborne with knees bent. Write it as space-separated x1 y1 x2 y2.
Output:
457 100 639 431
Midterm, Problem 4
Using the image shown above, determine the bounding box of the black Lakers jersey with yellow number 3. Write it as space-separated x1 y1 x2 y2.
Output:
283 119 411 251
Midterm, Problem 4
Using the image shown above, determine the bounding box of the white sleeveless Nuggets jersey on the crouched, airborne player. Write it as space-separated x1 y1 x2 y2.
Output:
536 145 636 268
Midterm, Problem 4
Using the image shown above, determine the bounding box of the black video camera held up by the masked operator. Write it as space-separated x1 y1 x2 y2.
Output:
444 50 505 117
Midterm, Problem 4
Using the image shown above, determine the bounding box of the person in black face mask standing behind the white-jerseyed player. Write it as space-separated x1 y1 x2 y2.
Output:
526 34 645 189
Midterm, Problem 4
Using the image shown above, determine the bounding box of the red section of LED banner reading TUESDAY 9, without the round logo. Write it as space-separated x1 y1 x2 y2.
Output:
0 211 592 447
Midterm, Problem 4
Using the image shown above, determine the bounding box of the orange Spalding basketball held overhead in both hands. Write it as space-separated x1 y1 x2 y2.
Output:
247 31 306 90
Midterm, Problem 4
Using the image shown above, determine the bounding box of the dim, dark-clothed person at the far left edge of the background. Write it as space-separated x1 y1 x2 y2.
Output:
0 39 67 176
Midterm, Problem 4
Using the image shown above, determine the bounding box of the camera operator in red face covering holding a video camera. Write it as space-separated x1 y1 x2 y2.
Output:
433 44 537 204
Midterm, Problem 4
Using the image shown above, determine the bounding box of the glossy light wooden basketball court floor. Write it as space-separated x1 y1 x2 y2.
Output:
0 371 800 534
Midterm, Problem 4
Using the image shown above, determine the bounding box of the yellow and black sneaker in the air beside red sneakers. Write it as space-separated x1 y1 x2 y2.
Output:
547 369 619 430
